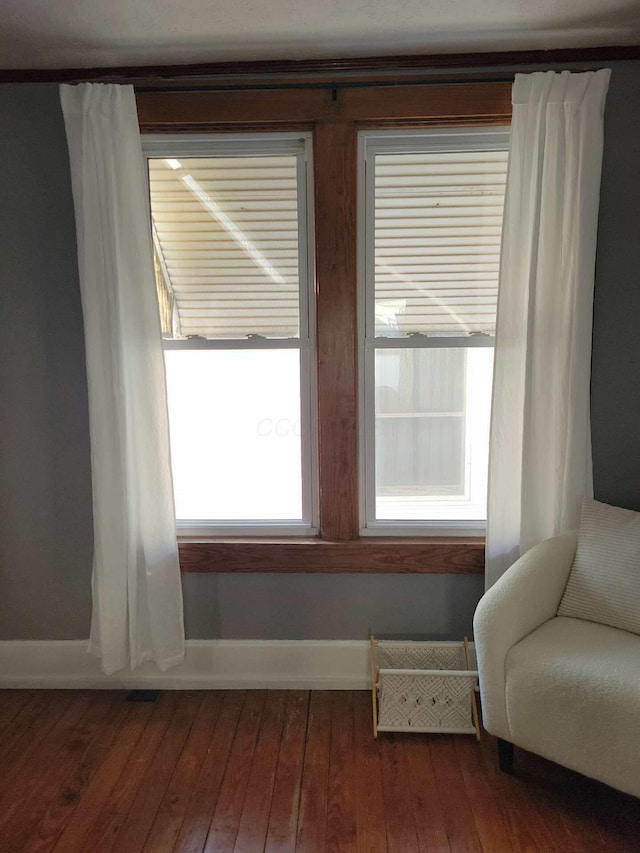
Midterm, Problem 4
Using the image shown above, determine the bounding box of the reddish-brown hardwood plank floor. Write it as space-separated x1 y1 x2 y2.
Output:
0 690 640 853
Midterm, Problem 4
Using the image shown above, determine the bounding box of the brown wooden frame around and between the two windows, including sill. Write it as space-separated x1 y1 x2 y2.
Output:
137 80 511 573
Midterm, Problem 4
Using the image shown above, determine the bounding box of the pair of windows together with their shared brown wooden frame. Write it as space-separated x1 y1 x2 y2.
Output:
136 80 511 573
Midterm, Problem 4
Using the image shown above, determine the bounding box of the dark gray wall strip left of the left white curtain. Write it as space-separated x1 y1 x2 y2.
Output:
0 86 92 639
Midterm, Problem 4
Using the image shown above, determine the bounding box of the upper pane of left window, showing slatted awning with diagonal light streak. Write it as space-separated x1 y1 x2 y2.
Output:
149 154 300 339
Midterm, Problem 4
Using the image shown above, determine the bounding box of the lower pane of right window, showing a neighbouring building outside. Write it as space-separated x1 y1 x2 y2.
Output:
375 347 493 521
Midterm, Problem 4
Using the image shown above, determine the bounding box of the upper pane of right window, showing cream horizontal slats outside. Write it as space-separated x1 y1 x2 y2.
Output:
374 151 507 335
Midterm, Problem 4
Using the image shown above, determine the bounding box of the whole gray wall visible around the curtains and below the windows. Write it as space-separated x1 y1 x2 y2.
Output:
0 62 640 639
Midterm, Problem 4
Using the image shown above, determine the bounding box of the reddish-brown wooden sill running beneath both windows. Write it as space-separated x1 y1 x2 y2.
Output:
178 536 484 574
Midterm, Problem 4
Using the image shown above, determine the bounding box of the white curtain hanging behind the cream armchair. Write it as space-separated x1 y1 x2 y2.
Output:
486 69 611 586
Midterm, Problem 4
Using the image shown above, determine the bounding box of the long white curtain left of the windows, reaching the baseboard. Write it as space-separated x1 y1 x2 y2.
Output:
60 83 184 673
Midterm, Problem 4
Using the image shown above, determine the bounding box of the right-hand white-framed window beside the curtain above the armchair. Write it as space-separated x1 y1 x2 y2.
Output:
360 128 508 535
